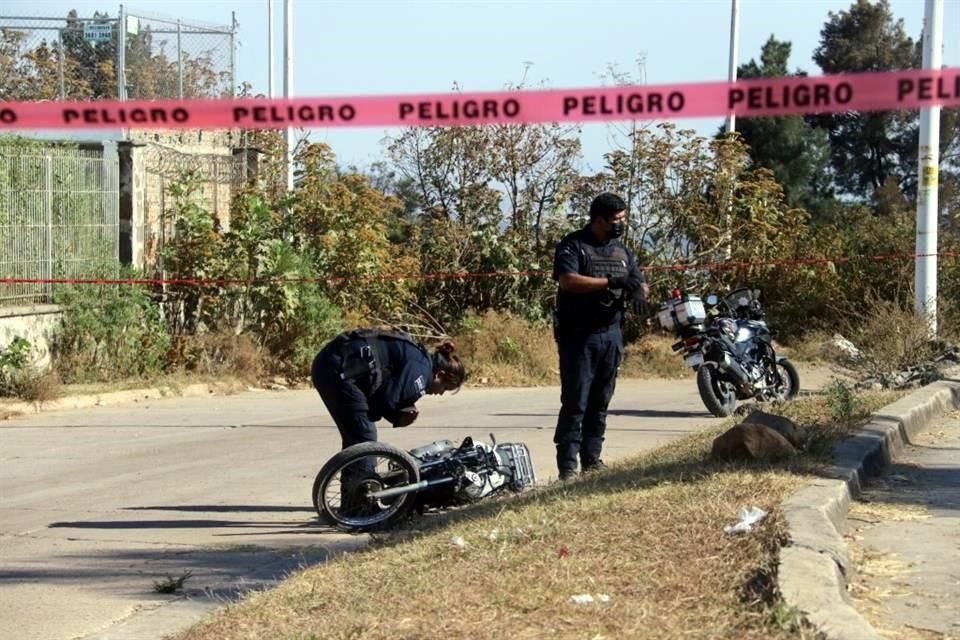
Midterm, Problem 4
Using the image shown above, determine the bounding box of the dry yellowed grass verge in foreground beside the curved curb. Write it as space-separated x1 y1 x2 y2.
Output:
171 394 891 640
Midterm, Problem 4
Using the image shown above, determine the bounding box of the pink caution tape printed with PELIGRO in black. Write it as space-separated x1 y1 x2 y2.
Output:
0 67 960 130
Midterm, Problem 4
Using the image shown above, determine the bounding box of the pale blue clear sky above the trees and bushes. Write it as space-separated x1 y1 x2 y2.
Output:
7 0 960 171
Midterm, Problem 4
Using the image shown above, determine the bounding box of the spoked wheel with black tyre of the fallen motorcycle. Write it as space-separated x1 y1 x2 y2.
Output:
313 442 420 533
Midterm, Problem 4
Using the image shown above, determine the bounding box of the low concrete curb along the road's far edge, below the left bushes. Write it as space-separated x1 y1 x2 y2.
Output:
0 382 250 417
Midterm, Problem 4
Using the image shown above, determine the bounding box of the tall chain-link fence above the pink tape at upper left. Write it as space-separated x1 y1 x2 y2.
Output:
0 7 236 100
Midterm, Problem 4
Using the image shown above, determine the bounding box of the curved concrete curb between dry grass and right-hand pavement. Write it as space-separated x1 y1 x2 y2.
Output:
777 370 960 640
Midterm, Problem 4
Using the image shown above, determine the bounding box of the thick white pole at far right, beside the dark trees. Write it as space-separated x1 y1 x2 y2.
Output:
914 0 943 337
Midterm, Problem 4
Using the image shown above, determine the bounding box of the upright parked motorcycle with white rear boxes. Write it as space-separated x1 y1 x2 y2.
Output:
657 288 800 418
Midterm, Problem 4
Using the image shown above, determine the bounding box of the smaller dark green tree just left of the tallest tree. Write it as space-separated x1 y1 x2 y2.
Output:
718 35 832 218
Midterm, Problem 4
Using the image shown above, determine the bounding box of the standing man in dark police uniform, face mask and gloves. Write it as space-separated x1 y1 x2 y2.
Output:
553 193 650 480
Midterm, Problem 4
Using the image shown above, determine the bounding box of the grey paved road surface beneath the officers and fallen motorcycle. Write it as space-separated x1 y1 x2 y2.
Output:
0 364 840 640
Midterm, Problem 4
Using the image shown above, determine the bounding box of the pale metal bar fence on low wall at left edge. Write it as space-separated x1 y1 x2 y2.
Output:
0 146 119 305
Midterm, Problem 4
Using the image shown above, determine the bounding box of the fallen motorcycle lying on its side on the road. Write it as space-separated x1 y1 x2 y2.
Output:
313 434 536 533
